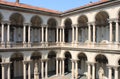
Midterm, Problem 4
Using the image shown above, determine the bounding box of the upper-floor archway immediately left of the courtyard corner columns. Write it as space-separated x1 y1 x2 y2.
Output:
47 18 57 43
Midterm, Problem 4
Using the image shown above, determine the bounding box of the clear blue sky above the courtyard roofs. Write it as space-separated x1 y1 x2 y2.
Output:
7 0 99 12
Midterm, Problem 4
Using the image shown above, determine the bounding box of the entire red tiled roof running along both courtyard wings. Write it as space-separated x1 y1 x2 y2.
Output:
0 0 109 14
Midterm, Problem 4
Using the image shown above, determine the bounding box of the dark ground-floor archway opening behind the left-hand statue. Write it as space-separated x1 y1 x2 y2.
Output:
31 51 42 78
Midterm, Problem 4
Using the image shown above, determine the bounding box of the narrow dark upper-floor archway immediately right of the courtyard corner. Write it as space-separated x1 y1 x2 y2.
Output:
64 18 72 43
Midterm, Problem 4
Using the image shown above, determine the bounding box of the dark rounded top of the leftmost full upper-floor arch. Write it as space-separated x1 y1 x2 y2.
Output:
9 13 25 26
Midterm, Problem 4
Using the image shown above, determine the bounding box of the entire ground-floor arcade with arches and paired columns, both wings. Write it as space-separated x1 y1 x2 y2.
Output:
0 50 120 79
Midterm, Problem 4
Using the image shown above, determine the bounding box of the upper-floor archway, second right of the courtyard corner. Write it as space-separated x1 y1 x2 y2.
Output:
78 15 88 42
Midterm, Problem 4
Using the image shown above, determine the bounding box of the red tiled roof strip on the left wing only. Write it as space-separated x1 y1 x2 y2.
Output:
0 1 60 14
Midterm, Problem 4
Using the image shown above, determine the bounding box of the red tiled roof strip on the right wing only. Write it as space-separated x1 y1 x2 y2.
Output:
63 0 110 13
